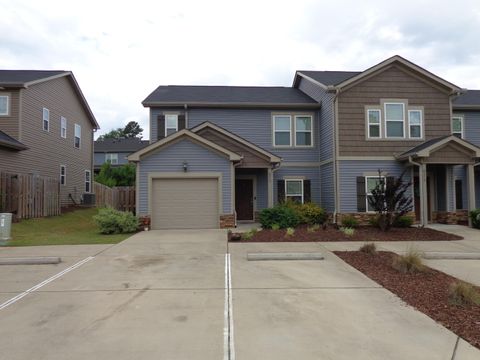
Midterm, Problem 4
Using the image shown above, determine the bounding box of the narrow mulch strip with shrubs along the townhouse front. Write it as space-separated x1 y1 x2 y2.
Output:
231 225 463 242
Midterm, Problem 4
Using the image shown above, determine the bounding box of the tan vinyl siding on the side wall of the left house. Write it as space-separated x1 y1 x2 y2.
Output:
0 77 93 205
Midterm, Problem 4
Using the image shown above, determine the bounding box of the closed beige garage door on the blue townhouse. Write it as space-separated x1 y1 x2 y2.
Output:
150 178 219 230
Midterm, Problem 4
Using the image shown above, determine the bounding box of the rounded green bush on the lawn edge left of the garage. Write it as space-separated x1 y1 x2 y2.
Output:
93 208 139 234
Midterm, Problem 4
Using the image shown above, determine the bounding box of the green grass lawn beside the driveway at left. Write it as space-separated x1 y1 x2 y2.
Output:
7 208 132 246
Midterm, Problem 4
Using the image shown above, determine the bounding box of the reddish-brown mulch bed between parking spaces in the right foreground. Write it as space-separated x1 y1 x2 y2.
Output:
334 251 480 348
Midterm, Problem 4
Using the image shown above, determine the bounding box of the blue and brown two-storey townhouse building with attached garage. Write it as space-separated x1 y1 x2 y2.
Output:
128 56 480 229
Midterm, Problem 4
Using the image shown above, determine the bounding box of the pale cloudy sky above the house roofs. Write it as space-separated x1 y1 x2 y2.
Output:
0 0 480 139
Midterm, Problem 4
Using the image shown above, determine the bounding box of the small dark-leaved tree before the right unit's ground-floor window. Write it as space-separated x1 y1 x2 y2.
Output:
368 170 413 231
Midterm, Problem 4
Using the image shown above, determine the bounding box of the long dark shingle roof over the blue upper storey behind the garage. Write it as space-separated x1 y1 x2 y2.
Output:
142 85 319 107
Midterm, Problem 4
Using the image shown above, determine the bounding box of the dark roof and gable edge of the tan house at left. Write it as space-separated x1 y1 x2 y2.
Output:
0 70 100 129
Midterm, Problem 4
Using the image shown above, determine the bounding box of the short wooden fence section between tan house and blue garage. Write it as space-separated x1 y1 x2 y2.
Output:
93 182 135 213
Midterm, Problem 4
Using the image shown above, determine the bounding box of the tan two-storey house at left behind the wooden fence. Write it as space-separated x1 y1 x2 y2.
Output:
0 70 99 206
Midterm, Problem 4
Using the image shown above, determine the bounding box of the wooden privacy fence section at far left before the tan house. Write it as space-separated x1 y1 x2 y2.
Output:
0 171 60 220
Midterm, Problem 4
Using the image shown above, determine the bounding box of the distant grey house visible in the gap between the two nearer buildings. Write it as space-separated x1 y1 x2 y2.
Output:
94 138 150 173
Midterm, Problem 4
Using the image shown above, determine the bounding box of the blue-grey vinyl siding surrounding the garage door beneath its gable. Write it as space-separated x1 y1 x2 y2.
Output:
137 140 232 215
